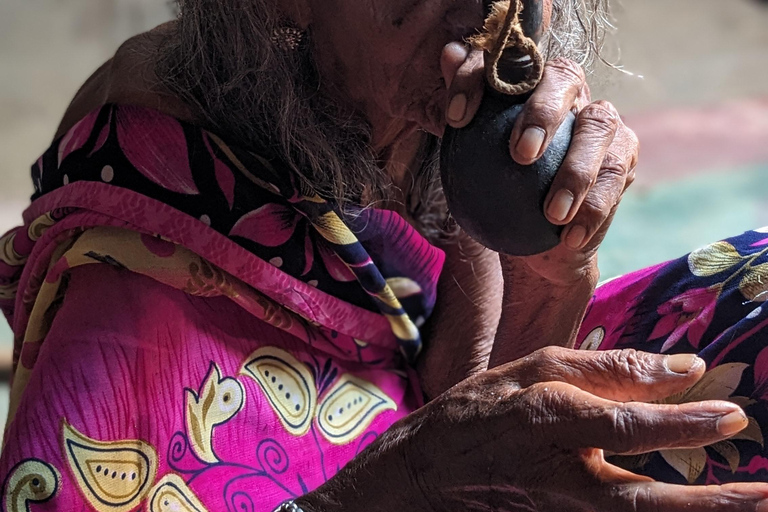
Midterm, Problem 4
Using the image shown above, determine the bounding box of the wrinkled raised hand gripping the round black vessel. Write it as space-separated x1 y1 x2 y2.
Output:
441 43 639 282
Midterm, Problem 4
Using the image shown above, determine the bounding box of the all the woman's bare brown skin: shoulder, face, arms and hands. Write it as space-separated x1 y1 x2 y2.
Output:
52 0 768 512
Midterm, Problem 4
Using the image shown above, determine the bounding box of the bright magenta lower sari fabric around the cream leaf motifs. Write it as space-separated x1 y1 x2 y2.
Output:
0 265 418 511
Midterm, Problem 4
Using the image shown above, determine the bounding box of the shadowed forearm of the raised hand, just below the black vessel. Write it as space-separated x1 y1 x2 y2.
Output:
489 258 599 368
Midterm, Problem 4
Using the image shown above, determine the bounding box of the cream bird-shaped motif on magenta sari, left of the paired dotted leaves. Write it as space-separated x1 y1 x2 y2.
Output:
186 363 245 464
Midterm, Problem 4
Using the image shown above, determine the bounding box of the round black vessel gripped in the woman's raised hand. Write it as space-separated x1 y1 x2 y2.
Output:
440 92 575 256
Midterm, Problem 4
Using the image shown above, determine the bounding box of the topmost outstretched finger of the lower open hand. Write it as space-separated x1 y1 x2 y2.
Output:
513 347 706 402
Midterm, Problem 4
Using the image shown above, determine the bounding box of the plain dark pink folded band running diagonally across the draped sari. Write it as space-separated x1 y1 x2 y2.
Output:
17 182 398 350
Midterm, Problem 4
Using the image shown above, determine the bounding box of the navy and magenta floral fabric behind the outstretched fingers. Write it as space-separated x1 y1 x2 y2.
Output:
577 229 768 484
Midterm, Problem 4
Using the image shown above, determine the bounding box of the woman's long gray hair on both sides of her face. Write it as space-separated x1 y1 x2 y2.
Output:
157 0 609 240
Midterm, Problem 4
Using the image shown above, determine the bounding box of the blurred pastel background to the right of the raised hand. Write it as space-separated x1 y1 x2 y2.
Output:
593 0 768 278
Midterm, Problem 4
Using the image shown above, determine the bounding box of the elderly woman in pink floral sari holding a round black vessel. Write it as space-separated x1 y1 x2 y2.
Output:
0 0 768 512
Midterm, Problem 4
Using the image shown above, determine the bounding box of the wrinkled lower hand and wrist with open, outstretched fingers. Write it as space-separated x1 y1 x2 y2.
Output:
297 347 768 512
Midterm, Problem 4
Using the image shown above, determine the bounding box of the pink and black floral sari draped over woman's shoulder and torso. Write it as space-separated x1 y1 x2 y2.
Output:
0 106 443 512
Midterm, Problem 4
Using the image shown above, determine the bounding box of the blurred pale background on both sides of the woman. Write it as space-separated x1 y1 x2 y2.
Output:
0 0 768 424
